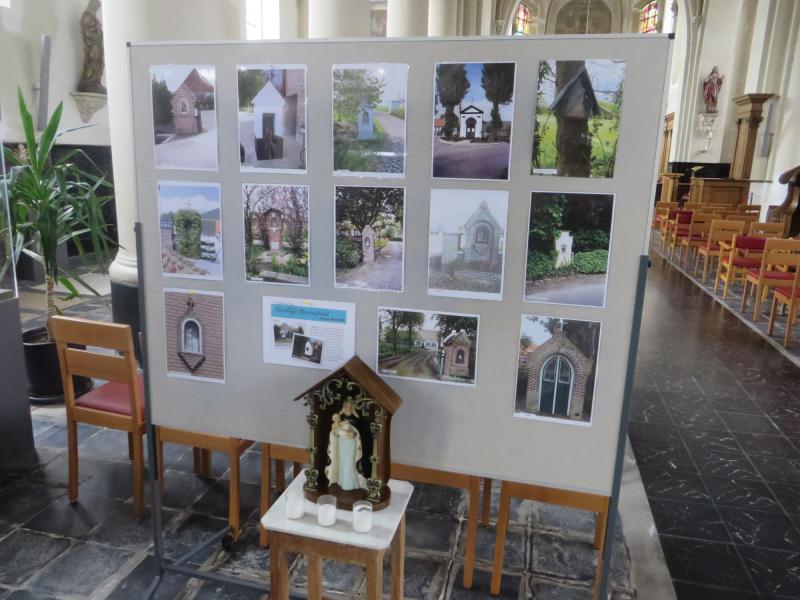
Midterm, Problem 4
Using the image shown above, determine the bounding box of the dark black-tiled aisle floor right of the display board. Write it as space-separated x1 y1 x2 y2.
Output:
628 255 800 600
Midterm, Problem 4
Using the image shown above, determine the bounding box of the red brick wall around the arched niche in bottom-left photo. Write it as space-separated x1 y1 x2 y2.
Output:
164 291 225 379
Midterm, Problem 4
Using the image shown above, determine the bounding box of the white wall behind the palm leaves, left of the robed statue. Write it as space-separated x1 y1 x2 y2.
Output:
0 0 109 145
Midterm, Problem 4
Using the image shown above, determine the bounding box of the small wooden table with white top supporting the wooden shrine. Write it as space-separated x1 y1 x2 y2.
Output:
261 473 414 600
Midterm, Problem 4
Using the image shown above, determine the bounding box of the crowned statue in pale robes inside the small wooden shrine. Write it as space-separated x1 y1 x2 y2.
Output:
325 400 367 491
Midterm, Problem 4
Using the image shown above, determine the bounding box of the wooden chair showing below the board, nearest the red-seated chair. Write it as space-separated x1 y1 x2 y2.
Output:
156 425 253 542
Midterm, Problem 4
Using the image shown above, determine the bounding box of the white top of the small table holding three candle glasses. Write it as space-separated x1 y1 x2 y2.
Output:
261 473 414 550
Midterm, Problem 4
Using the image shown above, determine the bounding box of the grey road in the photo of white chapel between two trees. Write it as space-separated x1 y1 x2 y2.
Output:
433 138 511 179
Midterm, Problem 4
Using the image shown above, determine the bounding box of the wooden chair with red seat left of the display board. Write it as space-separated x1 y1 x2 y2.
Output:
50 316 145 516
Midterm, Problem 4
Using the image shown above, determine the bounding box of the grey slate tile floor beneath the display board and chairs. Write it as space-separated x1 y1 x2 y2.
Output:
0 278 636 600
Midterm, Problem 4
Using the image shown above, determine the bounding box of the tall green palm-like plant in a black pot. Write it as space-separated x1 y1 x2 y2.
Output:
3 89 113 403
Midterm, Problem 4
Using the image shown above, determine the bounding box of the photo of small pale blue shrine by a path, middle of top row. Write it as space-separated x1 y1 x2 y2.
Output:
332 63 408 177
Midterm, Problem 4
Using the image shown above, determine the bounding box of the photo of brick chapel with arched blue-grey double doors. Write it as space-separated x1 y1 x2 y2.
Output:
514 315 600 423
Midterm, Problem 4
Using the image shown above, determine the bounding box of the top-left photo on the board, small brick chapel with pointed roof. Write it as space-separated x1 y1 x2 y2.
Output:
150 65 217 171
